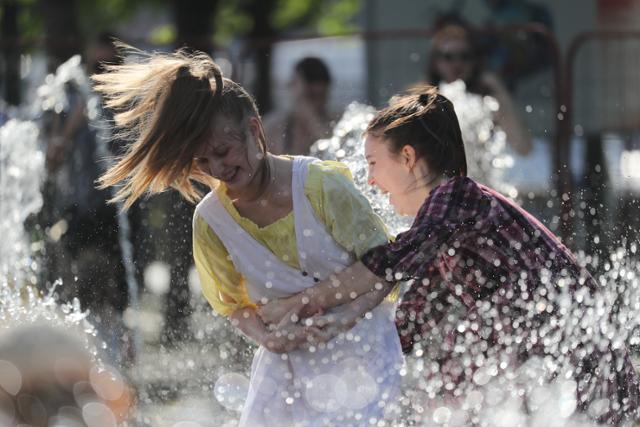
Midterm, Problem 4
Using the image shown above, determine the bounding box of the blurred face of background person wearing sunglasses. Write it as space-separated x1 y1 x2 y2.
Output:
433 39 473 83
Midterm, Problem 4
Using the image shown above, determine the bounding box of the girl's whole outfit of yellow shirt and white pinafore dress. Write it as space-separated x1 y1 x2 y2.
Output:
193 157 402 426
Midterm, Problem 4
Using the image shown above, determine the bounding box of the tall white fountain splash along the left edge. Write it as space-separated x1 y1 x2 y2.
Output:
0 56 95 334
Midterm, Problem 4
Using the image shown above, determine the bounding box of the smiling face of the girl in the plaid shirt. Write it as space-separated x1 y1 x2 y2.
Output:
364 134 424 215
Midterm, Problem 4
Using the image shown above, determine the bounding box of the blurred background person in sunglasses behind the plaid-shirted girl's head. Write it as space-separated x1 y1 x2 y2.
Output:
427 25 532 155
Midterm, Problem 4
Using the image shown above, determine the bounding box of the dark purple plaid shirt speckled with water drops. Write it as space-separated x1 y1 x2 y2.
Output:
362 177 640 421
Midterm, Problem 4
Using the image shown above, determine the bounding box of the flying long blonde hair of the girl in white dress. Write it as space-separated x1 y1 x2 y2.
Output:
91 44 264 209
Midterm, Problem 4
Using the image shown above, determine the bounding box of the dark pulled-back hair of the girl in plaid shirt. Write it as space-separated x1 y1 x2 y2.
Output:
366 85 467 178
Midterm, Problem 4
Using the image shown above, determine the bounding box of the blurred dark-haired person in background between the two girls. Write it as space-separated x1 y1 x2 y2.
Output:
264 57 335 155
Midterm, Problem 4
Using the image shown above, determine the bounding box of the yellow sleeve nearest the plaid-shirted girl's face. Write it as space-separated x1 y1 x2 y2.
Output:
305 161 389 259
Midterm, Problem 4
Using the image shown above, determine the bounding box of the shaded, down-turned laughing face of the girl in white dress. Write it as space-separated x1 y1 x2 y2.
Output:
196 116 264 193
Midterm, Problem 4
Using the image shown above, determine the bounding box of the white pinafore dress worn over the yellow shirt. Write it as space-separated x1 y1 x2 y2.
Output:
196 157 403 427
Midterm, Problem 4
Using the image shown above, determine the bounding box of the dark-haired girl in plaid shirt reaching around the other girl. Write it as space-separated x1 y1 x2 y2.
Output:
260 86 640 424
